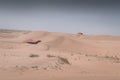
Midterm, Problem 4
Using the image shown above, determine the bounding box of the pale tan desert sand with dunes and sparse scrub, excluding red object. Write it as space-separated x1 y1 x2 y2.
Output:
0 30 120 80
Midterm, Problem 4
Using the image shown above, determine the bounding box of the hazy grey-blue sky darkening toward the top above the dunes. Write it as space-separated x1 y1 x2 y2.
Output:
0 0 120 36
